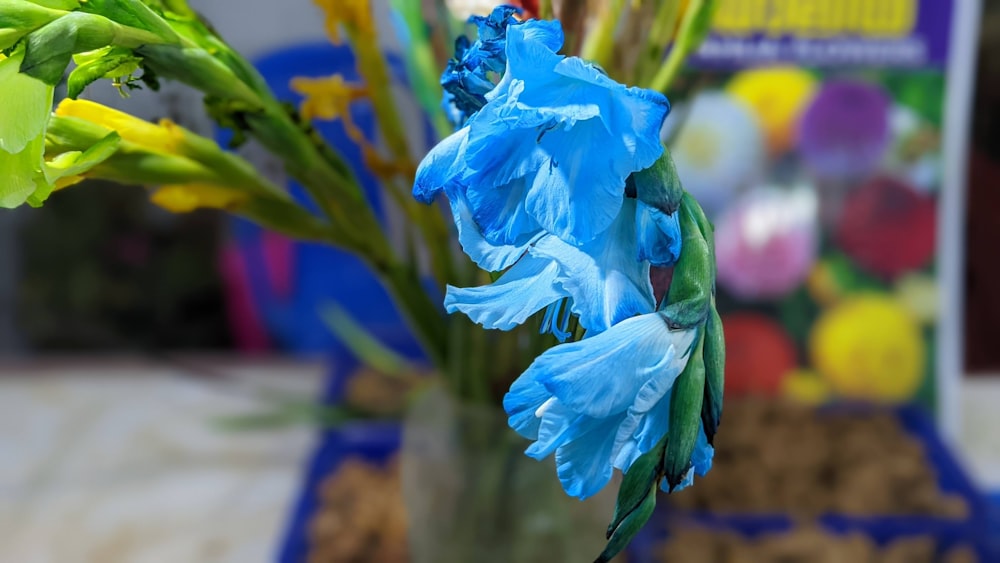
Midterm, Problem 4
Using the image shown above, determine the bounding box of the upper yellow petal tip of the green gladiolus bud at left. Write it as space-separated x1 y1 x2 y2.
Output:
55 98 184 154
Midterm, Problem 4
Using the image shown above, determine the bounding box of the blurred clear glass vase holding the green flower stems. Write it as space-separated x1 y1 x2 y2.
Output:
400 387 615 563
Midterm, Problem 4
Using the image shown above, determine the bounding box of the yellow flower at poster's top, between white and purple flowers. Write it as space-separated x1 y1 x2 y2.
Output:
726 67 816 154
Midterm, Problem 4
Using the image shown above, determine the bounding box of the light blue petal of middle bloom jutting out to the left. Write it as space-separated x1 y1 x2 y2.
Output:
444 252 563 330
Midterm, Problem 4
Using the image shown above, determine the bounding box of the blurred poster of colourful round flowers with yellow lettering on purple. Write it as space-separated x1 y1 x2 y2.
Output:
664 0 976 418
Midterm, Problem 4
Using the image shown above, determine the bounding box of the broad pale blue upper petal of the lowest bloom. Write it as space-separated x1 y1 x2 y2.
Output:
522 313 694 418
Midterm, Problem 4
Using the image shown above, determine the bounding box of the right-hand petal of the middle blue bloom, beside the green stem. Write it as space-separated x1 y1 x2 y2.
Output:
528 200 655 333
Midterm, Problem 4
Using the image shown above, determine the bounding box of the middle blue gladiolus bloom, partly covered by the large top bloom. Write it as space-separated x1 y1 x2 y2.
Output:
445 196 680 338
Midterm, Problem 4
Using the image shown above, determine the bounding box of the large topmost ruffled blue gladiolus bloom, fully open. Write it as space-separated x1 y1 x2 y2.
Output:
414 20 670 246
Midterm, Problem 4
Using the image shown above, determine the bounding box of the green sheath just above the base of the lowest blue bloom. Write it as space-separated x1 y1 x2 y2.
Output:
660 199 715 328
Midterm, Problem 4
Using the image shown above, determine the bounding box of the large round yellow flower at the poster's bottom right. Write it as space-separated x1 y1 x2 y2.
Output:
810 293 925 401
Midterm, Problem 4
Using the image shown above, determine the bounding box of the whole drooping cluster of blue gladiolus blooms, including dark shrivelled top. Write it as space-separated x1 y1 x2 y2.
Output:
413 8 712 499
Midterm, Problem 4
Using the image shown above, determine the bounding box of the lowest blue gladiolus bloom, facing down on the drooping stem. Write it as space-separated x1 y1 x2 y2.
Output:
504 313 713 499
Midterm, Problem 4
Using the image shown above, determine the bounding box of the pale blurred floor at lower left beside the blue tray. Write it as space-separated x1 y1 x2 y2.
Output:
0 361 322 563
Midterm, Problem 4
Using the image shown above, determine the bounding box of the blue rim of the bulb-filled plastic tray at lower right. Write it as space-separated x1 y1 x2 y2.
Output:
630 406 1000 563
